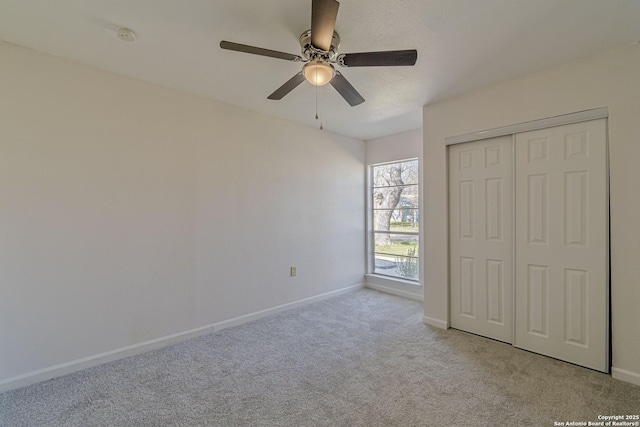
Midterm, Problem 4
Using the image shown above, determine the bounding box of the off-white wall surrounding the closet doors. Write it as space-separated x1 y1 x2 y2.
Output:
423 44 640 384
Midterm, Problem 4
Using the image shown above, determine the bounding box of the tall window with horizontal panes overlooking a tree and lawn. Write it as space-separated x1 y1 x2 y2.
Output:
371 159 420 281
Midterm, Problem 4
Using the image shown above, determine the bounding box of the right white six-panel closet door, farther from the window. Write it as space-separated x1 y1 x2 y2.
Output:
515 119 609 371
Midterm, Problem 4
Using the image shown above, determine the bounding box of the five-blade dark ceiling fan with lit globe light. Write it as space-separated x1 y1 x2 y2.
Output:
220 0 418 107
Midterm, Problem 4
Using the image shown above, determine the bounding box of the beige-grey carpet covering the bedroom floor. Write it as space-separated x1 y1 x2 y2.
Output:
0 290 640 426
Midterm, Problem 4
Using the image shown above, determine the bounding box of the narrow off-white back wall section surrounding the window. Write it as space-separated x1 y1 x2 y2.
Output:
365 129 424 301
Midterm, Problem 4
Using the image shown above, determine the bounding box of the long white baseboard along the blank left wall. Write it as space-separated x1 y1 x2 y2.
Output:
0 283 364 393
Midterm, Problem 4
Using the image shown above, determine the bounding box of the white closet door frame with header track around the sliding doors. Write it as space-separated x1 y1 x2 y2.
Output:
445 107 611 372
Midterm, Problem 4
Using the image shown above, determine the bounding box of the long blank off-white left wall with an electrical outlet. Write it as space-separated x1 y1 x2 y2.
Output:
0 43 365 391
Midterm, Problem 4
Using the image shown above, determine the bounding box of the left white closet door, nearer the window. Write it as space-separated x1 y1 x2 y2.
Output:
449 136 513 343
